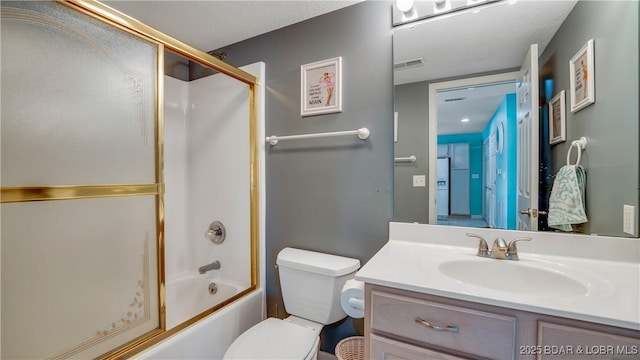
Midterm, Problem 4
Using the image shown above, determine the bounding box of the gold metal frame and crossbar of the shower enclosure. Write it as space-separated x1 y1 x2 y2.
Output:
0 0 260 359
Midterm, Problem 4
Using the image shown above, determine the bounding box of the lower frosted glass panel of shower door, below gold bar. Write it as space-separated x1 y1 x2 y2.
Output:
2 196 159 359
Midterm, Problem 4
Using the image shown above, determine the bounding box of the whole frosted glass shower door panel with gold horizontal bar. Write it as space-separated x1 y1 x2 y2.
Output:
0 1 163 359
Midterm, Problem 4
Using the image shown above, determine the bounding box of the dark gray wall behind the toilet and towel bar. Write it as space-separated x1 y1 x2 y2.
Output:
214 1 393 351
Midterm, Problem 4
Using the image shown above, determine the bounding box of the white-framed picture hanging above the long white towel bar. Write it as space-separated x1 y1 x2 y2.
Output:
300 57 342 116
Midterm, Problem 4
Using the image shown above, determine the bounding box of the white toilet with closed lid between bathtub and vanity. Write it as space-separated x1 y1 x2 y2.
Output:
224 248 360 360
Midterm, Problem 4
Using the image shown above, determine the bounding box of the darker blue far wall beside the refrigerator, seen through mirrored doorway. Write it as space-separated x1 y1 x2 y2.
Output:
438 133 483 216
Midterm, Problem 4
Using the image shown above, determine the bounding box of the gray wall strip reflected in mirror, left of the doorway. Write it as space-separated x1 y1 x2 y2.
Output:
394 81 429 224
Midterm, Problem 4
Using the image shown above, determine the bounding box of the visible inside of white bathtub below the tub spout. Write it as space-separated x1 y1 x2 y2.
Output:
166 273 244 329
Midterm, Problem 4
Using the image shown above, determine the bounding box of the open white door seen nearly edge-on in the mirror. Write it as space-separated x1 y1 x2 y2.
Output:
516 44 539 231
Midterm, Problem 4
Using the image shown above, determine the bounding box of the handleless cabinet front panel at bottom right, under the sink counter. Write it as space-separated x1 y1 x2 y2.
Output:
536 321 640 360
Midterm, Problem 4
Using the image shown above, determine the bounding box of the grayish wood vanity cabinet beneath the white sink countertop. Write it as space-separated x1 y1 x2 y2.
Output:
365 283 640 360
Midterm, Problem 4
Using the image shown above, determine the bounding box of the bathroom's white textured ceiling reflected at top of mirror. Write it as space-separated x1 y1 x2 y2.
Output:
393 0 577 84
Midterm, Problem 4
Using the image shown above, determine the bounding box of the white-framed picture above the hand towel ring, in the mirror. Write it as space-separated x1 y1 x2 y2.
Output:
569 39 596 112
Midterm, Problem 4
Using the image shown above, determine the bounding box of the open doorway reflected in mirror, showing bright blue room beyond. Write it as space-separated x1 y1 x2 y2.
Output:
429 72 517 228
